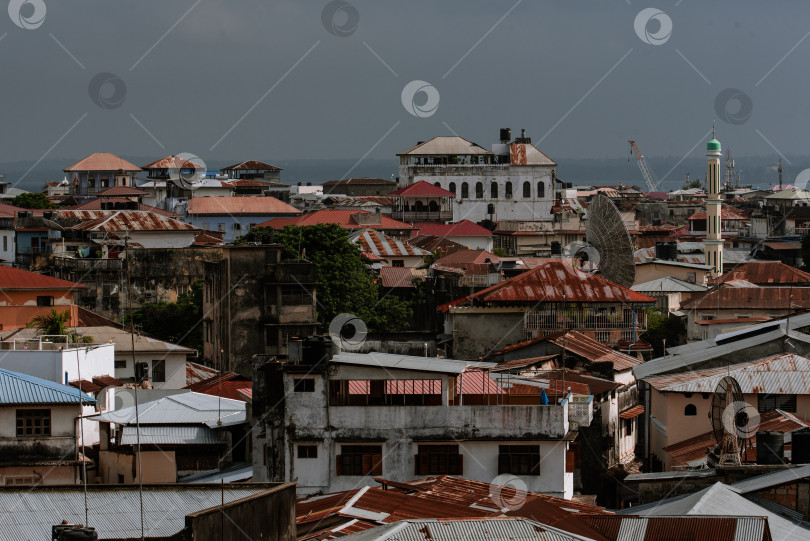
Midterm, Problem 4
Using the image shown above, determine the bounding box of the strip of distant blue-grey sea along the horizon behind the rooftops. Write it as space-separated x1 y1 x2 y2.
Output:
0 156 810 191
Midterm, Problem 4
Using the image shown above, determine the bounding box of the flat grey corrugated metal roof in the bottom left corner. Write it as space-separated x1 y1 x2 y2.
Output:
0 485 267 541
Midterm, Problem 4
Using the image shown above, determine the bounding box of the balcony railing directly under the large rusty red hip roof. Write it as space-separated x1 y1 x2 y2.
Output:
523 308 647 332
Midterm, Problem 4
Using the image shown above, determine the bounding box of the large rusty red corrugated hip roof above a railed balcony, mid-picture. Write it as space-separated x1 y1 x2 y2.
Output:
439 260 655 311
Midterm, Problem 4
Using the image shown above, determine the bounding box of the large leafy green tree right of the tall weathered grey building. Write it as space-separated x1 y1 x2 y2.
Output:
274 224 413 332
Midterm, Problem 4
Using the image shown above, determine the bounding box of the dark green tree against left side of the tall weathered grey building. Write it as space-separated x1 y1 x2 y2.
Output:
124 280 203 351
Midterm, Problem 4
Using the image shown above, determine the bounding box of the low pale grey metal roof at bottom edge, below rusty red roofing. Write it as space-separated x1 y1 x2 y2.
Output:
345 517 591 541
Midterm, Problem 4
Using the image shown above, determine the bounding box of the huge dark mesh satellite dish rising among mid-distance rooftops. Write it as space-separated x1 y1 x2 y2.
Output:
585 194 636 287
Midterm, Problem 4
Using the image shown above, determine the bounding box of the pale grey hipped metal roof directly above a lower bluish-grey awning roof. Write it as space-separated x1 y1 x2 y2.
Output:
91 392 245 428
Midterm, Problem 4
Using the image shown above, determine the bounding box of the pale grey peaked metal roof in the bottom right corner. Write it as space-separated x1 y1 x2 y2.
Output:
616 482 810 541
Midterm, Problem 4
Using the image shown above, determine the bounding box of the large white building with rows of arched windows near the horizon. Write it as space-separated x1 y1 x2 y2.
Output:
397 130 558 222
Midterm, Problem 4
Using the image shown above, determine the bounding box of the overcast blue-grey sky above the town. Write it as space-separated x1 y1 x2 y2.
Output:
0 0 810 171
